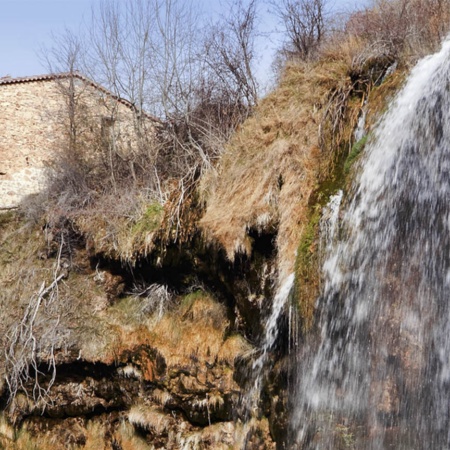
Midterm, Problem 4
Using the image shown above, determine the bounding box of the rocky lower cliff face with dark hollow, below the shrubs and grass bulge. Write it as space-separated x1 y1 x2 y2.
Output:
0 207 280 449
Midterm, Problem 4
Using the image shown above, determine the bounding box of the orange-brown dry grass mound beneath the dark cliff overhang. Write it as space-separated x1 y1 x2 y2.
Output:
101 291 251 370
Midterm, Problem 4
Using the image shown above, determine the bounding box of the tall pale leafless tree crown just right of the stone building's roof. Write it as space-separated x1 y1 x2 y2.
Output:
86 0 204 121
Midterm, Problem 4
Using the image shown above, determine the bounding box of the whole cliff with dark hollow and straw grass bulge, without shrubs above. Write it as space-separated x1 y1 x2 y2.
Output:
0 56 395 450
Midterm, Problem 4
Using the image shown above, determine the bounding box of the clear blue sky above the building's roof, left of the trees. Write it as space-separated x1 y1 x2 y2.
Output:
0 0 368 77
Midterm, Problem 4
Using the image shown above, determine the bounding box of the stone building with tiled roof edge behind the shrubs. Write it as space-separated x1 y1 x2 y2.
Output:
0 73 157 209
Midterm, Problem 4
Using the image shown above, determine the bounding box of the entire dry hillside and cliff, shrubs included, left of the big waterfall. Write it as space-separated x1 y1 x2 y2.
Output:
0 0 450 450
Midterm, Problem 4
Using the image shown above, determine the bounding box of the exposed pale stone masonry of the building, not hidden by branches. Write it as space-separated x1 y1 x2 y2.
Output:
0 74 156 210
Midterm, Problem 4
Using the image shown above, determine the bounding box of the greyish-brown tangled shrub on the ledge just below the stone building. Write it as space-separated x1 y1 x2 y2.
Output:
36 134 169 262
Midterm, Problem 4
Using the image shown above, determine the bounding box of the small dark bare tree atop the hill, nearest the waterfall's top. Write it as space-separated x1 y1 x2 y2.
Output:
271 0 327 59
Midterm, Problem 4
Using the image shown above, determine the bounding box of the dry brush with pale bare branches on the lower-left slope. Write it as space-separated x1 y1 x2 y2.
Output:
0 215 122 410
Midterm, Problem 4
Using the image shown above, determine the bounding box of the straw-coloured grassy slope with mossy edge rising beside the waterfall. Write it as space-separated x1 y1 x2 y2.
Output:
200 1 450 323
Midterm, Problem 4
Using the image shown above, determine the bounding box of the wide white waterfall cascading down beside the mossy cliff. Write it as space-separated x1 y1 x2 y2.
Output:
289 36 450 450
